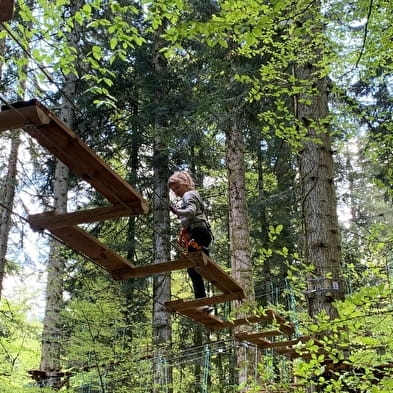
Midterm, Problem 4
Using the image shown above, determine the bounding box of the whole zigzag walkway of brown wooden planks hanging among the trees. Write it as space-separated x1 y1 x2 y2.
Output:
0 100 306 352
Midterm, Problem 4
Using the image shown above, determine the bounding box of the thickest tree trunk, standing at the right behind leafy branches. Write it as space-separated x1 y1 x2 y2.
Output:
297 64 344 318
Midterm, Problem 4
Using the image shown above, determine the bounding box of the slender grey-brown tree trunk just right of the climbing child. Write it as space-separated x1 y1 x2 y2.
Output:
226 114 255 385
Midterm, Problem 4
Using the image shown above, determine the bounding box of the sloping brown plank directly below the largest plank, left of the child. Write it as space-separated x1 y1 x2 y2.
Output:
47 227 135 280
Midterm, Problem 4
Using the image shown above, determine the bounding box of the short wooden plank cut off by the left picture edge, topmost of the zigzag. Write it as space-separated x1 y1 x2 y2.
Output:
0 99 51 131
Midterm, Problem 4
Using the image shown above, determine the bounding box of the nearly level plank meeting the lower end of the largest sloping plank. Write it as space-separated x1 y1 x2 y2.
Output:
28 202 142 231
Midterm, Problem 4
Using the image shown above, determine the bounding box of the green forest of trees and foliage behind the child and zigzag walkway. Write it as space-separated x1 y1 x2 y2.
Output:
0 0 393 393
